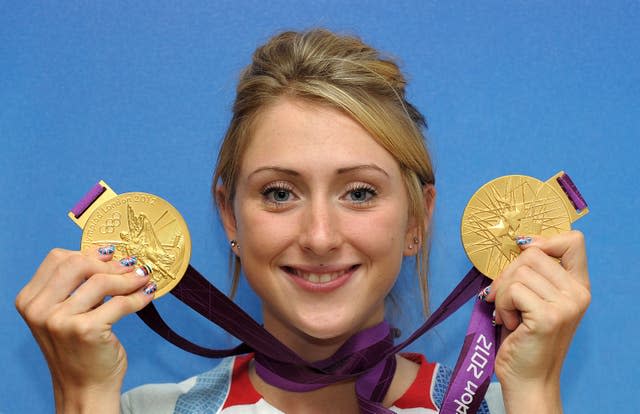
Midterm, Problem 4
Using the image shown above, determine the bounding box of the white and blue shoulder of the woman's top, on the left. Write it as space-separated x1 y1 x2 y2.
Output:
120 357 236 414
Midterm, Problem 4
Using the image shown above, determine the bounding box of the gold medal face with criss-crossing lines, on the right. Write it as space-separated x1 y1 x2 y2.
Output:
461 175 571 279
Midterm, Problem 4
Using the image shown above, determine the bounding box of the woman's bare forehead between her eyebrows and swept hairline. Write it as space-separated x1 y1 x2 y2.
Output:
242 98 399 172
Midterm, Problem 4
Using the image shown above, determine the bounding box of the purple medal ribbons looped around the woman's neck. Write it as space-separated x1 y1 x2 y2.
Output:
138 266 496 414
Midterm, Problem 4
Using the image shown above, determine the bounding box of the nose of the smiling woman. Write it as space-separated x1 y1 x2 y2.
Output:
300 200 342 256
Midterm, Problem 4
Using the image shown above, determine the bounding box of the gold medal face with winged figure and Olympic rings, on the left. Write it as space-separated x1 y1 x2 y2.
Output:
81 192 191 299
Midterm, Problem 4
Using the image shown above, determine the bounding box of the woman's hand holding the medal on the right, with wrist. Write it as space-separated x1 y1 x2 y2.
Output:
486 231 591 412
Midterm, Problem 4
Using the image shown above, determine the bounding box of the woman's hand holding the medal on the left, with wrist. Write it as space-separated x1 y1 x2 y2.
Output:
16 249 155 412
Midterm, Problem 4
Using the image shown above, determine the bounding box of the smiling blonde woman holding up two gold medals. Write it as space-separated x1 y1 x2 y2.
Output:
16 30 590 413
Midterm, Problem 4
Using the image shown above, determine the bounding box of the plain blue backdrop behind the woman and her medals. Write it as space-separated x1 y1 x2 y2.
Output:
0 0 640 413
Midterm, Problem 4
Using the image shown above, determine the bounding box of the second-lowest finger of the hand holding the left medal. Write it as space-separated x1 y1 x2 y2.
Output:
64 267 150 315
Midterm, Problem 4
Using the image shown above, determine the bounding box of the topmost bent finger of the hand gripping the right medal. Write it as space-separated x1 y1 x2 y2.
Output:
518 230 589 286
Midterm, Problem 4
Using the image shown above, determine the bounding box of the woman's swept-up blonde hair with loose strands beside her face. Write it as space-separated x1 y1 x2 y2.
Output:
212 29 435 312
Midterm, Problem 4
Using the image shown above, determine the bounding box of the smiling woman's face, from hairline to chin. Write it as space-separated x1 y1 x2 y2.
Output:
222 99 417 356
